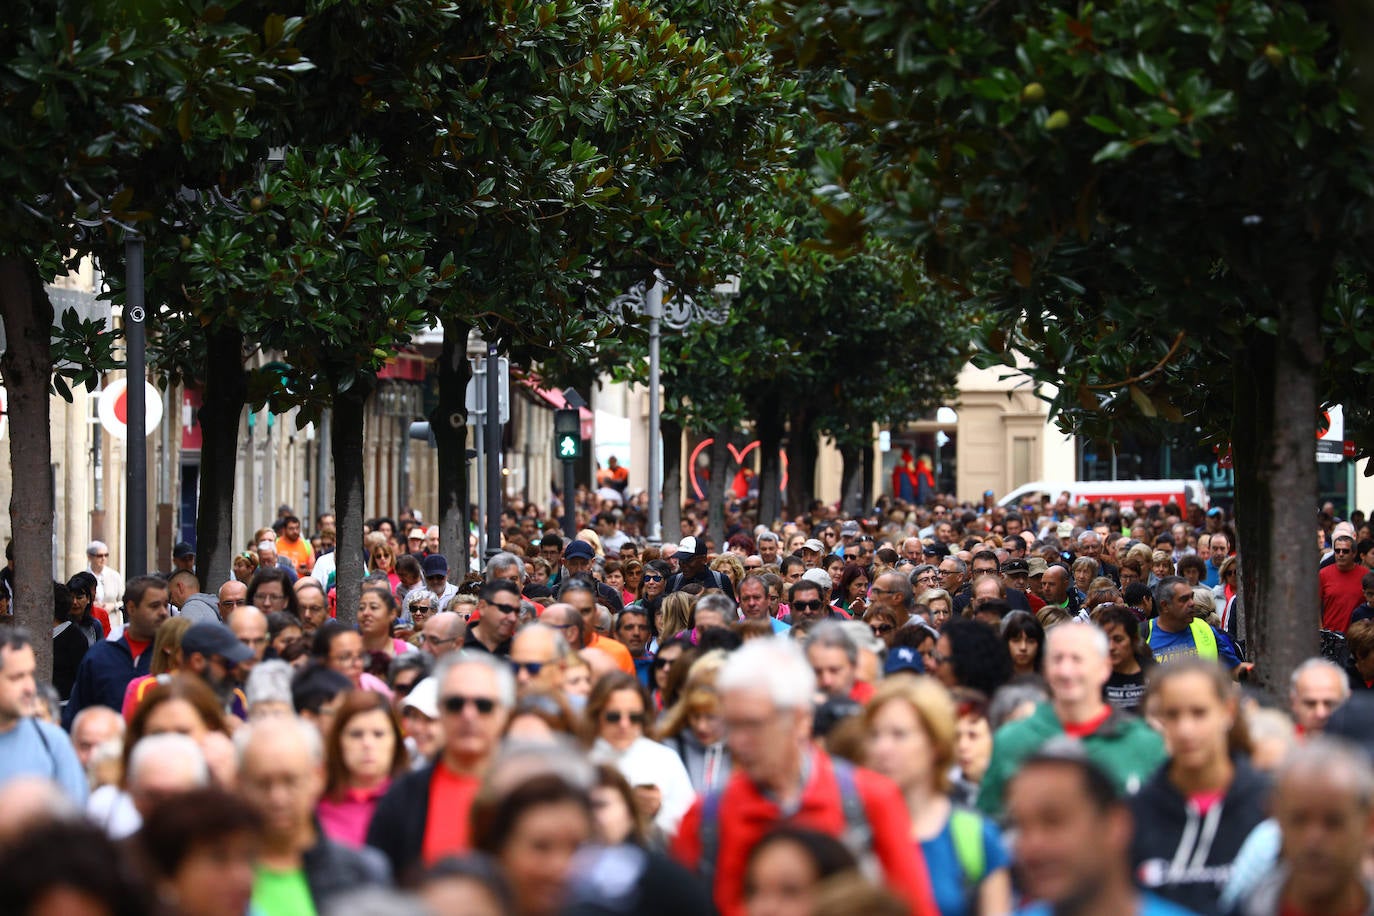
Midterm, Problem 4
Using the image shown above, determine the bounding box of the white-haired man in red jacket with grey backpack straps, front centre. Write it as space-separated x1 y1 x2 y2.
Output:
672 637 936 916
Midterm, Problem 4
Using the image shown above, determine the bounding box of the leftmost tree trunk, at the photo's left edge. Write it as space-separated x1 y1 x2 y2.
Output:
0 257 54 684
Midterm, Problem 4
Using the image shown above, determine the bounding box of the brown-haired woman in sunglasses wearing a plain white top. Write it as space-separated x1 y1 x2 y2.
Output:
585 672 697 836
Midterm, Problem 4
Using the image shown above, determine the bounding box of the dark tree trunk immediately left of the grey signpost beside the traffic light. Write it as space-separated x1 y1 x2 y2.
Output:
430 321 473 578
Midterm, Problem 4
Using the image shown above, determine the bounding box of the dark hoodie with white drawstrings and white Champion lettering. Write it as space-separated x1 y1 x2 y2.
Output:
1131 758 1270 915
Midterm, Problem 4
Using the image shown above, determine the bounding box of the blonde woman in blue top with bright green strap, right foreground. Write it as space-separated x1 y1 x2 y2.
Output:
863 676 1011 916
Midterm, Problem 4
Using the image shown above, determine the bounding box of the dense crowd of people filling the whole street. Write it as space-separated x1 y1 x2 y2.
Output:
8 494 1374 916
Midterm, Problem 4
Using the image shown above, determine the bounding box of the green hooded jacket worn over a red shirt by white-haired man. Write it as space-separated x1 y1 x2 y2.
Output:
978 703 1167 817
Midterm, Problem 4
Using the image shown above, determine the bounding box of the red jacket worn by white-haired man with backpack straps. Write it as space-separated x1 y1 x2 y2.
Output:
672 750 938 916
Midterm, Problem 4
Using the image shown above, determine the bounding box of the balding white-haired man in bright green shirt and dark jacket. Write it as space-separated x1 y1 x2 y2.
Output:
234 715 390 916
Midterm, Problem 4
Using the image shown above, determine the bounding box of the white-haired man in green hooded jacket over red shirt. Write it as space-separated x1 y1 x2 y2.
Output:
978 621 1165 817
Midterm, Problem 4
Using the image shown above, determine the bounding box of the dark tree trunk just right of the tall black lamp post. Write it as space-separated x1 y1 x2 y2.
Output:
195 327 249 595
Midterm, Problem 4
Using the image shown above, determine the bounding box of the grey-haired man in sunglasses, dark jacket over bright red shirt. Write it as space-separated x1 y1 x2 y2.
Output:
367 656 519 876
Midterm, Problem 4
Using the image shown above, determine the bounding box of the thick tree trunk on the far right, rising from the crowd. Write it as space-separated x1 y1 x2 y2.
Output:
1231 287 1322 696
